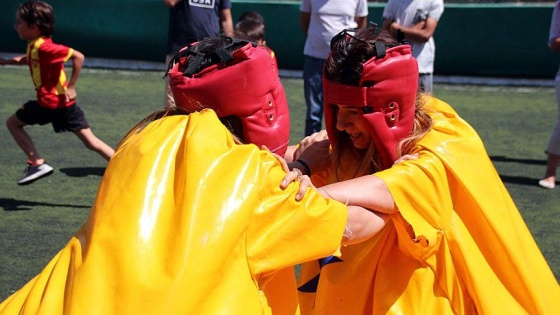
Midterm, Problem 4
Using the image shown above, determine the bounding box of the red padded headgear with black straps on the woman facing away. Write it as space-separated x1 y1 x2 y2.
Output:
168 39 290 156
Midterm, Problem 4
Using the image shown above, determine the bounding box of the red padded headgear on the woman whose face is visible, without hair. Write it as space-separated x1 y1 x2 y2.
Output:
323 44 418 169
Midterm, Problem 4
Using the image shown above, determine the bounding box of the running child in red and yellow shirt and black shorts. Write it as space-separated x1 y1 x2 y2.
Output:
0 1 115 185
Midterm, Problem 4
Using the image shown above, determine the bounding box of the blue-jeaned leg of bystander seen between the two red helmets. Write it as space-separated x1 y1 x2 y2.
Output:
303 56 325 136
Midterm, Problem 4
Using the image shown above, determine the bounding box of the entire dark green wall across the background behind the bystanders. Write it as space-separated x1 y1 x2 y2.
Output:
0 0 559 78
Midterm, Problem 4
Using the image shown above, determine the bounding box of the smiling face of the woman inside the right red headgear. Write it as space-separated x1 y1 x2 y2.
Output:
332 105 372 150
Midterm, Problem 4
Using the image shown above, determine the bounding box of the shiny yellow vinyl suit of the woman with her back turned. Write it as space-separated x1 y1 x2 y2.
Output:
0 110 347 315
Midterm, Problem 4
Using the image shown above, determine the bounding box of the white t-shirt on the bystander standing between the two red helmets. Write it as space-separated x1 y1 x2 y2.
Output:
300 0 368 59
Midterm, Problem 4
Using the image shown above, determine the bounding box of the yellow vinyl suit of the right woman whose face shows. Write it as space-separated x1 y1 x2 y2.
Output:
298 98 560 315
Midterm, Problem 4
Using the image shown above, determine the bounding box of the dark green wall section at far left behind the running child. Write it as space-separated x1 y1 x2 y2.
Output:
0 0 168 62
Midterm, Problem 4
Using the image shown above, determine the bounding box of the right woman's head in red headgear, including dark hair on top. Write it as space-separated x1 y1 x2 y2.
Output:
323 28 418 169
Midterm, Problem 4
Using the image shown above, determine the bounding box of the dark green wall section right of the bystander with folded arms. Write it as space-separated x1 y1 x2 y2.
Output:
434 4 559 78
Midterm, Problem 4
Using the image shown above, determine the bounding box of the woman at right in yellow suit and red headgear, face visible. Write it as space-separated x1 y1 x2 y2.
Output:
284 27 560 315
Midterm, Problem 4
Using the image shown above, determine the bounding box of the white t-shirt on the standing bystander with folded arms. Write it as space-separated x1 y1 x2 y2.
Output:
383 0 443 73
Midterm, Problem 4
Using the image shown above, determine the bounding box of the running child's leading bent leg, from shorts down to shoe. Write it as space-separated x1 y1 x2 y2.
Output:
6 102 45 165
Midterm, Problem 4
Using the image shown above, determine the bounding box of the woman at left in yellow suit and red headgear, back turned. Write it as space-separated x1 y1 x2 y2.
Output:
0 37 383 315
